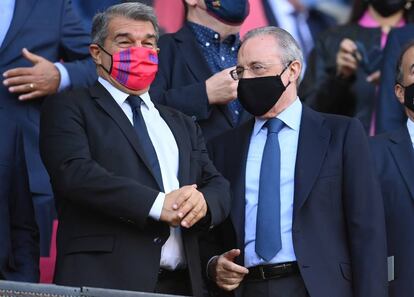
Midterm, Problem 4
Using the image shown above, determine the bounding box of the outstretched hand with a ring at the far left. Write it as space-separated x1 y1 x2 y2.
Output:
3 48 60 100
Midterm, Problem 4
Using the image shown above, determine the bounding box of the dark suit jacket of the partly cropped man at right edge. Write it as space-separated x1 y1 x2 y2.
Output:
370 126 414 297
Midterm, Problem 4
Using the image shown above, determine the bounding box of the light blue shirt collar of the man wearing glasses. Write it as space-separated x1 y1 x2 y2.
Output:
253 97 302 135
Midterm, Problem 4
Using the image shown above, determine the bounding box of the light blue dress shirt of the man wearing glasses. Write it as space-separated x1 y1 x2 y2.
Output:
244 98 302 267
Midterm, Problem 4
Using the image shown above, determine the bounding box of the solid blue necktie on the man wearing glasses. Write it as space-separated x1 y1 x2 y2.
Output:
255 118 284 262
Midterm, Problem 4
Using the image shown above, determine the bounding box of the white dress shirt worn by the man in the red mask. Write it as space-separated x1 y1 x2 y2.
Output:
98 77 186 270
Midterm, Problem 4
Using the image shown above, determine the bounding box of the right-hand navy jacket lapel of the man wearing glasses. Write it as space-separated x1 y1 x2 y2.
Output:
293 106 330 218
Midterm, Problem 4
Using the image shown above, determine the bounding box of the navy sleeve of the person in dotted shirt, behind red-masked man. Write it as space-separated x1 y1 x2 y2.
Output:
150 36 211 120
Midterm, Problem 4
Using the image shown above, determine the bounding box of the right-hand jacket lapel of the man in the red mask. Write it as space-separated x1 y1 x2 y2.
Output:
156 105 191 187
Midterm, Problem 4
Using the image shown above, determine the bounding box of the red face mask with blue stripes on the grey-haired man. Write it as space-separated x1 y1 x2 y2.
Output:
98 45 158 91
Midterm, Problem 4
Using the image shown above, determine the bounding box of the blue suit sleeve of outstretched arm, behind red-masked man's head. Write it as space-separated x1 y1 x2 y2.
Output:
59 0 97 87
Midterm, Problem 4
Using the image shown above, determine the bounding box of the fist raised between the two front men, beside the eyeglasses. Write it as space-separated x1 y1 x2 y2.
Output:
206 67 239 104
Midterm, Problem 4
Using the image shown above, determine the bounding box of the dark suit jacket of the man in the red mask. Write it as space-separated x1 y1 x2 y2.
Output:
40 83 230 296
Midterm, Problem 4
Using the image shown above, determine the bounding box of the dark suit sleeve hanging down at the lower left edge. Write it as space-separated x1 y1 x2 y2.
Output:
8 125 39 282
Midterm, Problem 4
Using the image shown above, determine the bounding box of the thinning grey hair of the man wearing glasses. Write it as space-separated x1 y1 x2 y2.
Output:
243 26 303 67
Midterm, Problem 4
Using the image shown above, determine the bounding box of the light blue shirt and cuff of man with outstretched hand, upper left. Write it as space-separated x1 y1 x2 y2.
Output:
0 0 71 91
